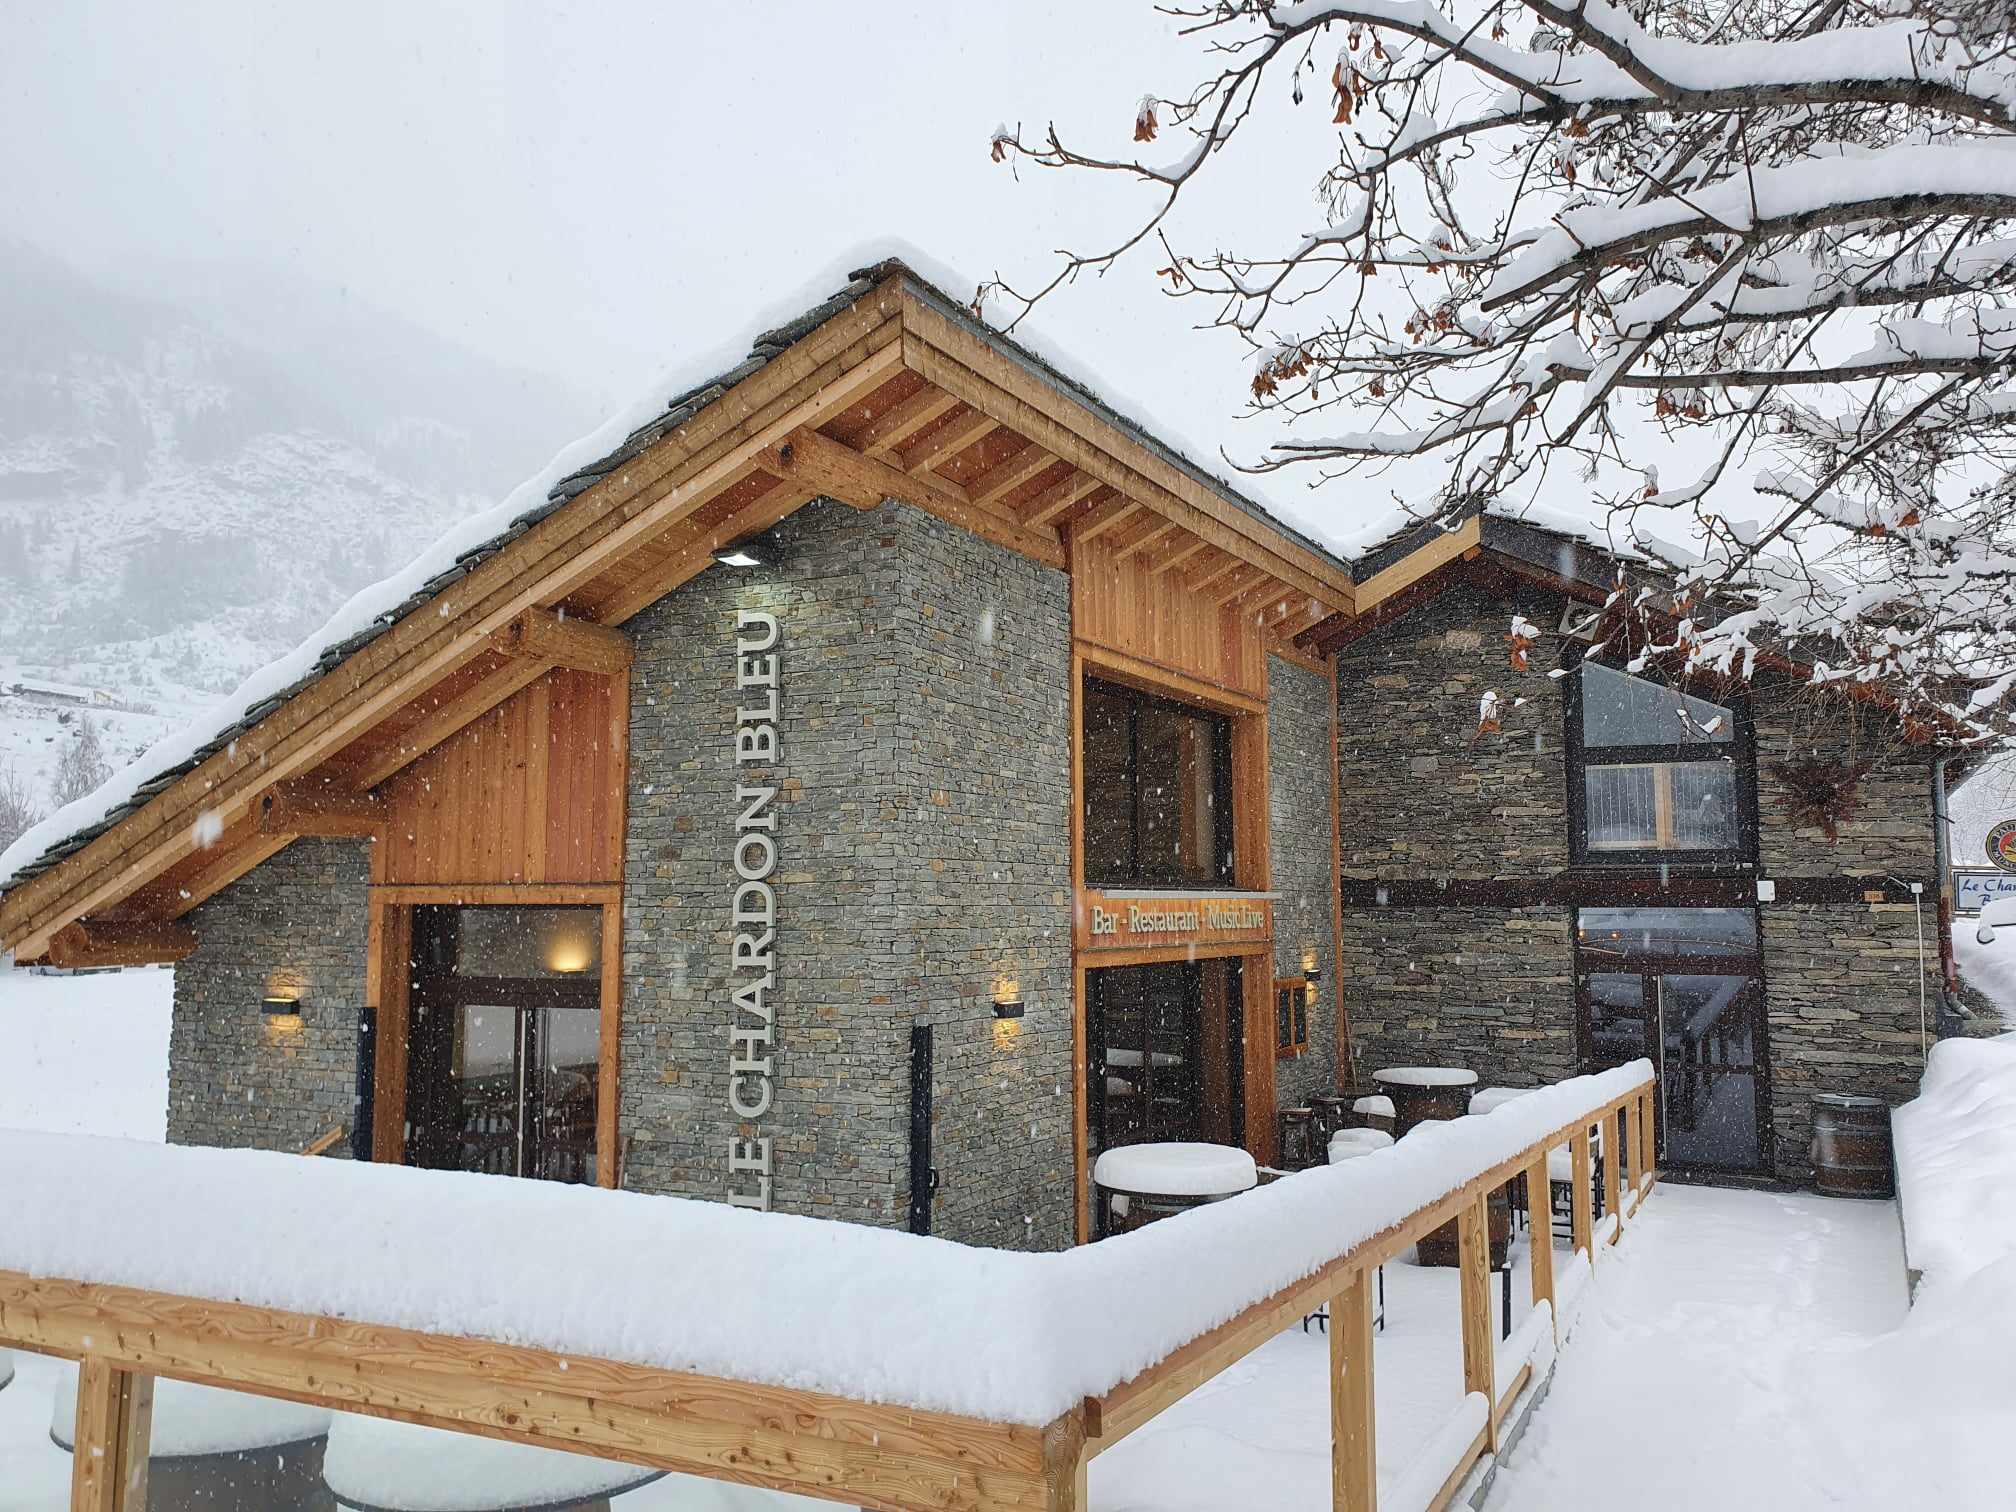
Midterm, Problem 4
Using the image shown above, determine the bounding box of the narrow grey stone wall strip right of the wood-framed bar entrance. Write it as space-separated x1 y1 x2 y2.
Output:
1266 657 1337 1107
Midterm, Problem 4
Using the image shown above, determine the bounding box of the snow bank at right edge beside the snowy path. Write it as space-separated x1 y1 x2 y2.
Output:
1891 1034 2016 1308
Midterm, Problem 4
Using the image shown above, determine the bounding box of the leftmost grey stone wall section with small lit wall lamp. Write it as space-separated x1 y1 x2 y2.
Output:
167 841 371 1155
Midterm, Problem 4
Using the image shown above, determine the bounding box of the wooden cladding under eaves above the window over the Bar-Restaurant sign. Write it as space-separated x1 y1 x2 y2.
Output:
1070 536 1266 698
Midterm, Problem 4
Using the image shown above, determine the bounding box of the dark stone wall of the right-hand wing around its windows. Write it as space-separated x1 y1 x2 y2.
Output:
1339 585 1937 1179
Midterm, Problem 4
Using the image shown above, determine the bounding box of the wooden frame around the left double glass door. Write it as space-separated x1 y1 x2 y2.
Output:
365 883 623 1187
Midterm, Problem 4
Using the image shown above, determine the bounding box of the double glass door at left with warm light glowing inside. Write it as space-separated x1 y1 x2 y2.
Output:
407 907 601 1181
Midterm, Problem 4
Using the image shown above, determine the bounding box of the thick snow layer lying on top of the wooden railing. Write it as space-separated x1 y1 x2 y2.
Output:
0 1060 1651 1425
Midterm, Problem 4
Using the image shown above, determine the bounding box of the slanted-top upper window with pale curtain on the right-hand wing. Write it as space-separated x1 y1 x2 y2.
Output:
1566 661 1756 863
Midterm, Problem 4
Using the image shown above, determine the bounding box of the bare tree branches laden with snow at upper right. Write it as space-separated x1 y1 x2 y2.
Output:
980 0 2016 740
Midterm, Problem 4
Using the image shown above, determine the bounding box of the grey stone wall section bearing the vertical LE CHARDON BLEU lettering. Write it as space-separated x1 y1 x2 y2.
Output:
621 500 1073 1246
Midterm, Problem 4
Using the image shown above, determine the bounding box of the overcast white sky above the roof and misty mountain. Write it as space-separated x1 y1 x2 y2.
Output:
0 0 1419 536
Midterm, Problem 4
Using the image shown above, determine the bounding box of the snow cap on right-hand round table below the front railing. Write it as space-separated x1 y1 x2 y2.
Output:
323 1413 665 1512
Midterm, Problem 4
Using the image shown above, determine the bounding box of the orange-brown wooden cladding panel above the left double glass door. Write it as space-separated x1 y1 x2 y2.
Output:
379 669 629 885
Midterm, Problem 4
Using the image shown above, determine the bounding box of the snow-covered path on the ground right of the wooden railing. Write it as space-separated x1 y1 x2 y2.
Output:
1490 1183 2016 1512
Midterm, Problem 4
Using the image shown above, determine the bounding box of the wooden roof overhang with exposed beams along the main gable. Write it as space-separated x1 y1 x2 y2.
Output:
0 264 1370 966
